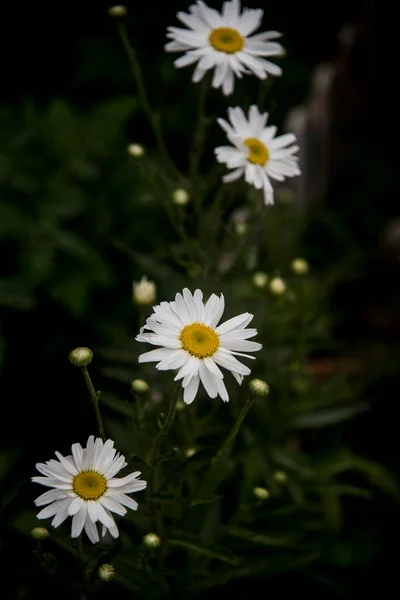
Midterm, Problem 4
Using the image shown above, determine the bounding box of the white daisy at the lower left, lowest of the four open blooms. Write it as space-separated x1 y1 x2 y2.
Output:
32 435 147 543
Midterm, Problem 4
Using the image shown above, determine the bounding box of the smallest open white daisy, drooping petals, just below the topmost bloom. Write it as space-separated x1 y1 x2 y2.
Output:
215 105 300 204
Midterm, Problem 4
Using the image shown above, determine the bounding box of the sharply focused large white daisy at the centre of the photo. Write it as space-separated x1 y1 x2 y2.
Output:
136 288 262 404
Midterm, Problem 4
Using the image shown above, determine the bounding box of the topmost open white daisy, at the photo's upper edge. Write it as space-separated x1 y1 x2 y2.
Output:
165 0 284 95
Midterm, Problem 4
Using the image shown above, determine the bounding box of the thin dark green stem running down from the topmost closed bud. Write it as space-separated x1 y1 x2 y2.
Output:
117 23 183 179
